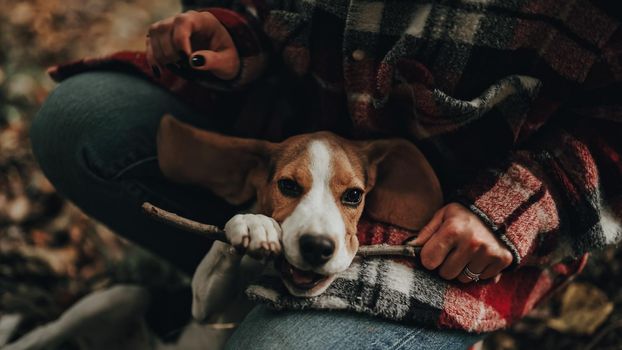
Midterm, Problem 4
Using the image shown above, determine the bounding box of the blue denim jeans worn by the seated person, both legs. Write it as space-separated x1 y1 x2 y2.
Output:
30 72 481 350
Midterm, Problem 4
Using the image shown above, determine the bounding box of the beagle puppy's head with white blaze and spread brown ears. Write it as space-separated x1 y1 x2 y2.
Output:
158 116 442 296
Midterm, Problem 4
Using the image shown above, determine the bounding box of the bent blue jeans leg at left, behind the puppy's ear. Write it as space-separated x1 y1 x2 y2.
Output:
30 72 241 274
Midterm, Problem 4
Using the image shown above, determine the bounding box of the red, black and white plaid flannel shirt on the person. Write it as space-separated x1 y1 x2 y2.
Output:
51 0 622 332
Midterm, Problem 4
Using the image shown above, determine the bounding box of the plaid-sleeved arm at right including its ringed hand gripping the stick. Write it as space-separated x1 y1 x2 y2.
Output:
412 26 622 282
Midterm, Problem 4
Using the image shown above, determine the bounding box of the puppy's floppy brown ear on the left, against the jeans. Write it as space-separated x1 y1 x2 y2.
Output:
157 115 274 204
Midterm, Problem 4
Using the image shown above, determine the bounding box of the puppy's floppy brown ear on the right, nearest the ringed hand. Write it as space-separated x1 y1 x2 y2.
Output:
363 139 443 230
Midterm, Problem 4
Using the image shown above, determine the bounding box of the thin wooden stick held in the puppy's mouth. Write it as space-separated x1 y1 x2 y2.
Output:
142 202 421 258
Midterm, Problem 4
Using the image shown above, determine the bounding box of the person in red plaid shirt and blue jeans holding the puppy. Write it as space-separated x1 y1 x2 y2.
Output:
32 0 622 349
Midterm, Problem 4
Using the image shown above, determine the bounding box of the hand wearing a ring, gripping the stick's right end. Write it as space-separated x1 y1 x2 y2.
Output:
409 203 513 283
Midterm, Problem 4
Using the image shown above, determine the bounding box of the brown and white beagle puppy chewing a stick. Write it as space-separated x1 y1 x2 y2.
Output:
6 116 442 350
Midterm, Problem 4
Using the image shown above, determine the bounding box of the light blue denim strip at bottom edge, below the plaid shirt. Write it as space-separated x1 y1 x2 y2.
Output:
226 305 484 350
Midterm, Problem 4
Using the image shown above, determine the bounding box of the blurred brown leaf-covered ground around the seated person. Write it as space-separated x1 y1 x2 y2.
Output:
0 0 622 349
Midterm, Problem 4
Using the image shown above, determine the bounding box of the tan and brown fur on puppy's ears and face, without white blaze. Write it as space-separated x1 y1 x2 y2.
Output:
158 116 442 233
